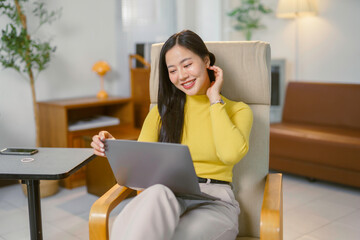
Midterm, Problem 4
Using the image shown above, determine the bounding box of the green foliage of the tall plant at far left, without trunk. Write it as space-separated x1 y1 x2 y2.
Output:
0 0 61 77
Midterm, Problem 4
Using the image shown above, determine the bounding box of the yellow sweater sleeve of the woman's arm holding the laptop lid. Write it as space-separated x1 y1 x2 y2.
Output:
138 105 160 142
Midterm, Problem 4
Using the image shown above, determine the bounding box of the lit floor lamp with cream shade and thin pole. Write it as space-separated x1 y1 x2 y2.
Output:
276 0 317 80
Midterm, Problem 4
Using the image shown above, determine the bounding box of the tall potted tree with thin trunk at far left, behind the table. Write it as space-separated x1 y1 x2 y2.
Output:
0 0 61 197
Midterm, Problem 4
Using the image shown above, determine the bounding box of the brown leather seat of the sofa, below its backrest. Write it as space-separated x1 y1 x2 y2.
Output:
270 123 360 171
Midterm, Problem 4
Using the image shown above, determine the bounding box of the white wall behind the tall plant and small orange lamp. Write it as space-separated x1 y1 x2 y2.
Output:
0 0 116 147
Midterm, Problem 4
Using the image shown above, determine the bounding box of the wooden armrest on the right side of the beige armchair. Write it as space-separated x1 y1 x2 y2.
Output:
260 173 283 240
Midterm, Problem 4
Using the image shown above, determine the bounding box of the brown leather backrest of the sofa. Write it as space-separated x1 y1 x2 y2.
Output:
282 82 360 130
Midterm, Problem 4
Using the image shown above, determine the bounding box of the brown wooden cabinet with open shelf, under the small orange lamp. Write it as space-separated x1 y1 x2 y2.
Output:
37 97 140 188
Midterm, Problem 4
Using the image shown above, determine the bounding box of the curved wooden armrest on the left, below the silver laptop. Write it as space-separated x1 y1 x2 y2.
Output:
89 184 135 240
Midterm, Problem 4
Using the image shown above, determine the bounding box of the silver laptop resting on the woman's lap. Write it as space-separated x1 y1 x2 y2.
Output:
105 140 218 200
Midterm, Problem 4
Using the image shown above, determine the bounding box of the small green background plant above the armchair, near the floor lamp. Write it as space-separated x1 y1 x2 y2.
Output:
228 0 273 41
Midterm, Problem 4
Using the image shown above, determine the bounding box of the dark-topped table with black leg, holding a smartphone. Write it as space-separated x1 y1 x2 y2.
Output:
0 148 94 240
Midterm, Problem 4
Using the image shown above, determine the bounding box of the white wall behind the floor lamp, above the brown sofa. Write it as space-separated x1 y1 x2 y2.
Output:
223 0 360 83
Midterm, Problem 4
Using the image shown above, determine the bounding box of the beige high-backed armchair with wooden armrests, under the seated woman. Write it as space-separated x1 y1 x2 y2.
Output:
89 41 283 240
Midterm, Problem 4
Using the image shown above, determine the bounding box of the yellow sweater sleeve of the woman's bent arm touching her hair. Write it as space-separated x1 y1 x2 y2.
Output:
210 102 253 165
